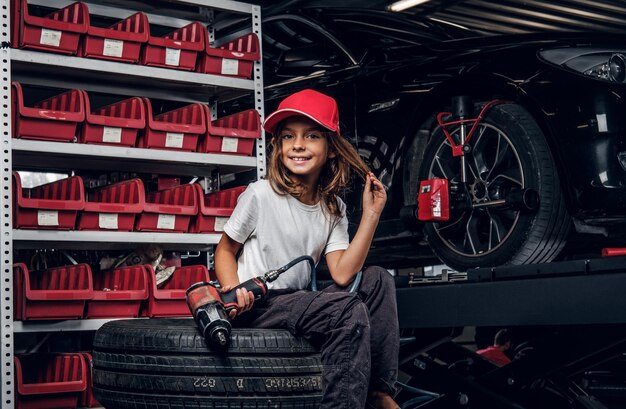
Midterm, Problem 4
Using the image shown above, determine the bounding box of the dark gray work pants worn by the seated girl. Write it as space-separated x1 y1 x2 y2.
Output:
235 267 399 409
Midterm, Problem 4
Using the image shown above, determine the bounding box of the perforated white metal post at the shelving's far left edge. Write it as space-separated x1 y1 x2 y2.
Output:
0 0 15 408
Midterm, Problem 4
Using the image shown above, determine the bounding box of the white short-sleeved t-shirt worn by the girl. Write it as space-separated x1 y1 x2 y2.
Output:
224 180 349 290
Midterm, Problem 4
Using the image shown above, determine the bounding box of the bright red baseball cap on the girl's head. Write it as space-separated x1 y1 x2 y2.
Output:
263 89 339 135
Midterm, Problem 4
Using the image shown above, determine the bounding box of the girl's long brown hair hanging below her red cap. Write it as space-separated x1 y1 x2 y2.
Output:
267 126 370 217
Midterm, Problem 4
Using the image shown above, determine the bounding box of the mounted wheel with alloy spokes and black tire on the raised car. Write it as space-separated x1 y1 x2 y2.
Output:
419 104 571 271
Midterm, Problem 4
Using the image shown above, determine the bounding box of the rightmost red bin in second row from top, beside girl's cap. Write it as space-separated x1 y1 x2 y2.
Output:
198 106 261 156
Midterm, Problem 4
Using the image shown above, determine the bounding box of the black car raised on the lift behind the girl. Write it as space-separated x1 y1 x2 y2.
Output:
229 8 626 271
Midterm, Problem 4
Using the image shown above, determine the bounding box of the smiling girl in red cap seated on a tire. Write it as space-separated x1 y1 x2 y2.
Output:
215 90 399 409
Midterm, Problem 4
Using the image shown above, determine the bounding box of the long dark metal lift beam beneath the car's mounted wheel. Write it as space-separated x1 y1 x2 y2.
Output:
397 268 626 328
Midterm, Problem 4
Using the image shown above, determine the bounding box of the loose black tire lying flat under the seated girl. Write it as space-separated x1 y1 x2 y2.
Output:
93 319 322 409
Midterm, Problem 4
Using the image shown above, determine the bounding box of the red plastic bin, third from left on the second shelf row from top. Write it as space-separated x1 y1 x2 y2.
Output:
138 98 206 152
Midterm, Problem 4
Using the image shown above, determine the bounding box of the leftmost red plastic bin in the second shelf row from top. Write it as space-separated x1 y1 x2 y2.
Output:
11 82 85 142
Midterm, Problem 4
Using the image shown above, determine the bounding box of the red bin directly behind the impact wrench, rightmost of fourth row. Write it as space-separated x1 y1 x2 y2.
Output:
144 265 209 318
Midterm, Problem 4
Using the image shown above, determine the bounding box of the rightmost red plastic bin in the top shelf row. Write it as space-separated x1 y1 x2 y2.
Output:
196 33 261 79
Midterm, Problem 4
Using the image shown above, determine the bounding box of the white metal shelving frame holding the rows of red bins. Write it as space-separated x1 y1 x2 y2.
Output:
0 0 265 409
